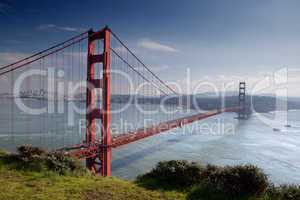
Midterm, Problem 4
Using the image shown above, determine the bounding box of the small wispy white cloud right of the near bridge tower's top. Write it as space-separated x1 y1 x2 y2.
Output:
138 38 179 52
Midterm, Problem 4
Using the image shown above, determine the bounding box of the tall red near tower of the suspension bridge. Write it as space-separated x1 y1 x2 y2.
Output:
85 27 111 176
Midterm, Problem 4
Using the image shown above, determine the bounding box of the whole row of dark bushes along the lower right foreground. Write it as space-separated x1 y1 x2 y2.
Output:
137 160 300 200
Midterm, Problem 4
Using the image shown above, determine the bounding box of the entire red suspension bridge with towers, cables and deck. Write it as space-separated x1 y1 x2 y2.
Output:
0 27 247 176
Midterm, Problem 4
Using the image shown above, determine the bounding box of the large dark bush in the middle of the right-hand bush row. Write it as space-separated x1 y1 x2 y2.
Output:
201 165 268 197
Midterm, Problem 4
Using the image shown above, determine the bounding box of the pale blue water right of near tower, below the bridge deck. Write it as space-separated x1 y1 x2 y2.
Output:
112 111 300 184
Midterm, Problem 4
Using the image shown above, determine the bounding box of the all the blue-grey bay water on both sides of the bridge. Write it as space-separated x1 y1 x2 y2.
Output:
0 99 300 184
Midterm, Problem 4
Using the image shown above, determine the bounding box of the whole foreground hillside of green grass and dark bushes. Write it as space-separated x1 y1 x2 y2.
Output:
0 147 300 200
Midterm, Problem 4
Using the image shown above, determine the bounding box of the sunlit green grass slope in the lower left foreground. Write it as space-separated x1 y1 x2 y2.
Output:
0 150 186 200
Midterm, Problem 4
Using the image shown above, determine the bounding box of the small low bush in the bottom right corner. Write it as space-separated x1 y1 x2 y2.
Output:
267 185 300 200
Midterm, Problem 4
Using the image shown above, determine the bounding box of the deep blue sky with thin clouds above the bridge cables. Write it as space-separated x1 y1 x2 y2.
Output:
0 0 300 94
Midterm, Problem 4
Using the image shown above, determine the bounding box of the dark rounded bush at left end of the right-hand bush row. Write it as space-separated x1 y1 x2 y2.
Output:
138 160 202 188
